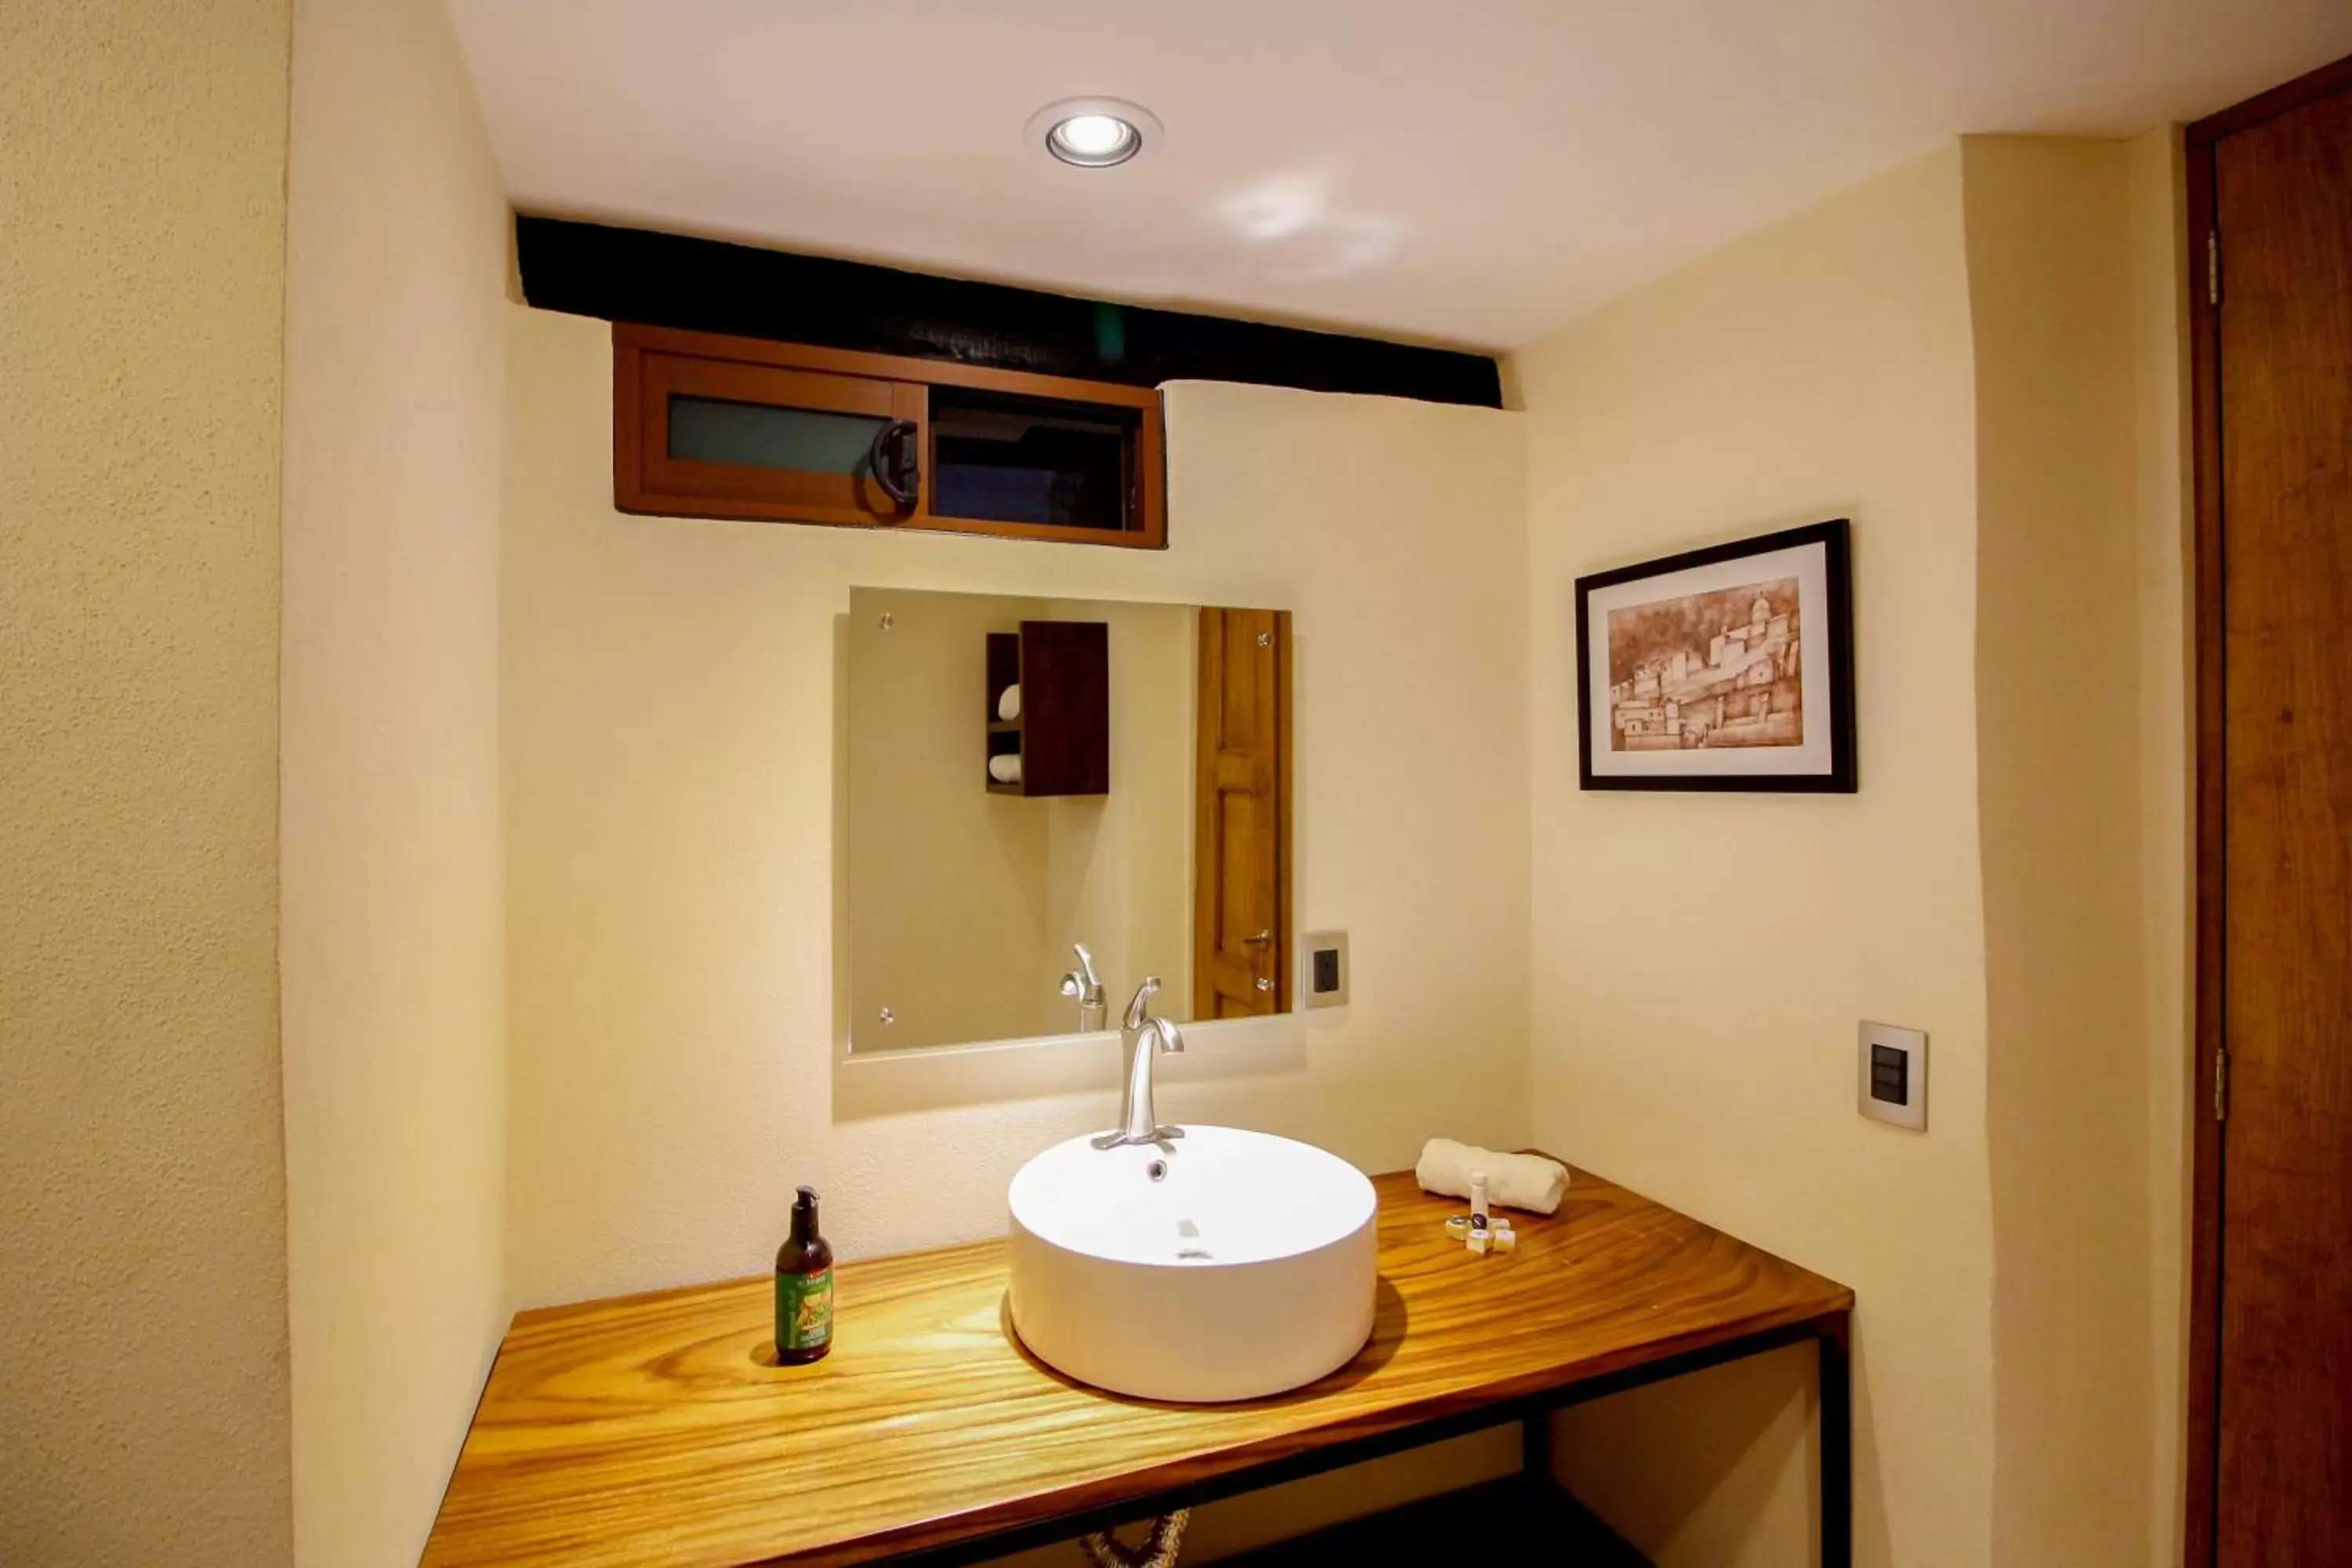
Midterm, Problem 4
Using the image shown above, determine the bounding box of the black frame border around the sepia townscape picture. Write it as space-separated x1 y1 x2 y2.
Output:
1576 517 1860 794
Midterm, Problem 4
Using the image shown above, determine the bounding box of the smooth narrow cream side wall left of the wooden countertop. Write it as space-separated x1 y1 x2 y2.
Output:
282 0 508 1568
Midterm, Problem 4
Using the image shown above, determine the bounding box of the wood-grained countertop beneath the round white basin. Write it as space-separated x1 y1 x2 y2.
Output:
423 1171 1853 1568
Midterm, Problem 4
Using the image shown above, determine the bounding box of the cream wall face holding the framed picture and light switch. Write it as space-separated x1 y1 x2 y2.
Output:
1517 148 1992 1568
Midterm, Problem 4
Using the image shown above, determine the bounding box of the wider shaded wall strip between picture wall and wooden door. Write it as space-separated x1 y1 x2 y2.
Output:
1962 136 2157 1563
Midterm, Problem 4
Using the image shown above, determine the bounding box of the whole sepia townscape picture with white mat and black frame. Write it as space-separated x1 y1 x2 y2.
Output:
1576 517 1856 794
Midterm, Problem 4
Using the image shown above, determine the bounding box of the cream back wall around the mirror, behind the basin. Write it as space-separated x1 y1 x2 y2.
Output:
501 308 1529 1307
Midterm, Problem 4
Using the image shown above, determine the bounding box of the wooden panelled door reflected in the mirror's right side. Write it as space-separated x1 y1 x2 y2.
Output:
1192 609 1291 1020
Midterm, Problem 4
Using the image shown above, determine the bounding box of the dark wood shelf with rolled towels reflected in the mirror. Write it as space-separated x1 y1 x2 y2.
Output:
988 621 1110 794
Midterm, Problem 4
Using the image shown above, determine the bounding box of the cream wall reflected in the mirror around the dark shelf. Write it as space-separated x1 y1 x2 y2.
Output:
835 588 1200 1051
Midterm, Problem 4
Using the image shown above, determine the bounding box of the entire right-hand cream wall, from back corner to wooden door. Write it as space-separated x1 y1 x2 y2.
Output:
1517 132 2187 1568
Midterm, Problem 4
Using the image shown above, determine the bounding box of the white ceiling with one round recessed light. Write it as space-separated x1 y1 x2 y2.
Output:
449 0 2352 348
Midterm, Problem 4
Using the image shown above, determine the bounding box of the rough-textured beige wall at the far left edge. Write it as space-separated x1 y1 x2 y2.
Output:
0 0 287 1568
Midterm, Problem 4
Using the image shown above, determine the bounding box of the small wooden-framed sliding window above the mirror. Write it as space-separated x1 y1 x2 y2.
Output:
612 325 1167 550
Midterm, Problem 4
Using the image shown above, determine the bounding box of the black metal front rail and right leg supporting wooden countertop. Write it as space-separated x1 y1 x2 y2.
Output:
887 1312 1853 1568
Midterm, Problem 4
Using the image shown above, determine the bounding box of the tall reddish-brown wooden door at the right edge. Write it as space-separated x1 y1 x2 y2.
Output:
2192 52 2352 1568
